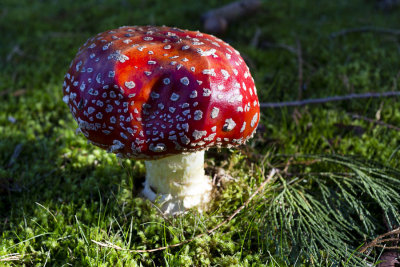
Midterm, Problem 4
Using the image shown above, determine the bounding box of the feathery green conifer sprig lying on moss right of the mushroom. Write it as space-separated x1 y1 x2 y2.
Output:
263 155 400 266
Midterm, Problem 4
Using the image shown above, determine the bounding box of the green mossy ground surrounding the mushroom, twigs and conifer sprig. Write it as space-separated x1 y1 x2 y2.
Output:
0 0 400 266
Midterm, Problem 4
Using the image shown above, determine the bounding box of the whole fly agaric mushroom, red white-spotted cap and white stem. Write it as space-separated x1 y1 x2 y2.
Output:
63 26 260 214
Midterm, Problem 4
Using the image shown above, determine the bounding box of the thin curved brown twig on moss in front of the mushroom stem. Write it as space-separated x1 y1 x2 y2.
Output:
92 169 277 253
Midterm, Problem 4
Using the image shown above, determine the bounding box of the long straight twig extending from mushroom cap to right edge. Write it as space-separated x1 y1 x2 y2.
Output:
260 91 400 108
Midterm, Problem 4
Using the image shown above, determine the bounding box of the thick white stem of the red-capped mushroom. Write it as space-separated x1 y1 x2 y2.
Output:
142 150 212 215
